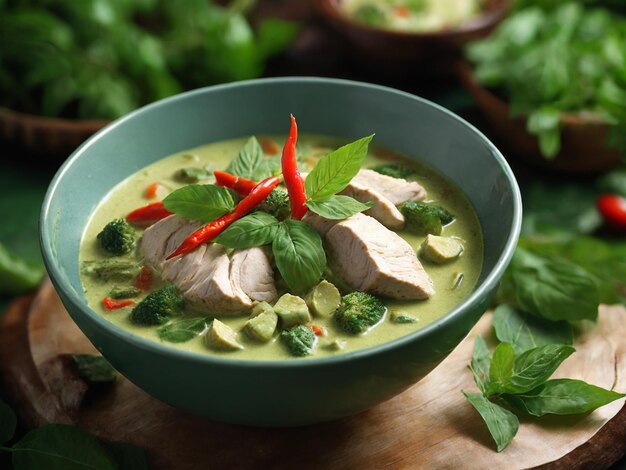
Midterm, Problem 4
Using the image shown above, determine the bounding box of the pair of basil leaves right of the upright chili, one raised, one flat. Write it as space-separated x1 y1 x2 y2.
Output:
304 134 374 220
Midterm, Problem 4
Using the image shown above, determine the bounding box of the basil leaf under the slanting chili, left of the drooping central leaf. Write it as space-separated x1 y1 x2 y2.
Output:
215 212 278 249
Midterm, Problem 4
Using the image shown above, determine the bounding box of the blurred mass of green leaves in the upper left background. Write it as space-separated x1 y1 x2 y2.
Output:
0 0 296 119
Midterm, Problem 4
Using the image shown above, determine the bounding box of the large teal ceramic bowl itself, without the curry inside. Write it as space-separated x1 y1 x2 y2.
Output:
41 78 522 426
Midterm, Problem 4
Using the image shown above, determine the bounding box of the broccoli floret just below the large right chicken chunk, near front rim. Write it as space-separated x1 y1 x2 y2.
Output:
335 292 387 335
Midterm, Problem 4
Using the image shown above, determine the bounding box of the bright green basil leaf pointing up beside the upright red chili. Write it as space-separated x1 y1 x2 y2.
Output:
304 134 374 201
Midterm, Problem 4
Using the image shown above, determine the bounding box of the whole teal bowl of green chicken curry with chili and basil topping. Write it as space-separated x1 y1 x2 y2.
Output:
40 78 522 426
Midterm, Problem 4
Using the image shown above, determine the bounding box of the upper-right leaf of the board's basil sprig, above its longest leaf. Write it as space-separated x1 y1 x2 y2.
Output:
503 343 576 393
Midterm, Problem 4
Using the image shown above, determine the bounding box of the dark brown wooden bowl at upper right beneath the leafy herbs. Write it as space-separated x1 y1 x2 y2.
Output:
457 63 622 174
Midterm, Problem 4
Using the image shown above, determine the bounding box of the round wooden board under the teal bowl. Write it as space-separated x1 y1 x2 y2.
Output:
0 281 626 470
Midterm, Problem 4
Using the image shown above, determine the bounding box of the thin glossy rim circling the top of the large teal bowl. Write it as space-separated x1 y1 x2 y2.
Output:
39 77 522 369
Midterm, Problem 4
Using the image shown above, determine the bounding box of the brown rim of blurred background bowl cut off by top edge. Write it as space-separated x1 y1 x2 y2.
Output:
315 0 511 40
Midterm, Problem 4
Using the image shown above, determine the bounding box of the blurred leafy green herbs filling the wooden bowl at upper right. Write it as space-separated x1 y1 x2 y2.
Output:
466 0 626 159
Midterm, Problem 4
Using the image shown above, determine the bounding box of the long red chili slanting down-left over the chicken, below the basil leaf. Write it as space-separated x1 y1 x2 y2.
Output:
165 176 280 259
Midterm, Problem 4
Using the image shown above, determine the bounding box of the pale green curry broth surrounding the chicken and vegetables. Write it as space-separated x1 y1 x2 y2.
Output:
80 135 483 359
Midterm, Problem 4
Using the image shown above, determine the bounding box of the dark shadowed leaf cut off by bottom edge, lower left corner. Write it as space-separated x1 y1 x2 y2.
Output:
12 424 118 470
